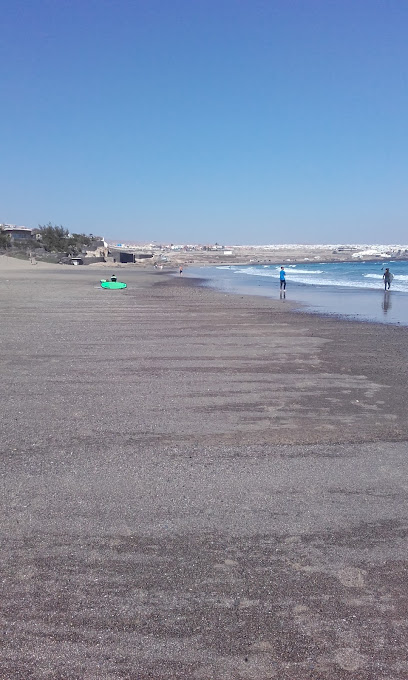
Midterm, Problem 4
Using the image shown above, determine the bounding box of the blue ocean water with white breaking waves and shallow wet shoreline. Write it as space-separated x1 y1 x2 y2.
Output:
185 260 408 325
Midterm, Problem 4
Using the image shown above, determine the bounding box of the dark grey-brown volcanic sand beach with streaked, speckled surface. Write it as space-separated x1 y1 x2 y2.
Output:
0 267 408 680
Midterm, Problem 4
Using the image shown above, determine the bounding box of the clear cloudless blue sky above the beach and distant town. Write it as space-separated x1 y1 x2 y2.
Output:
0 0 408 244
